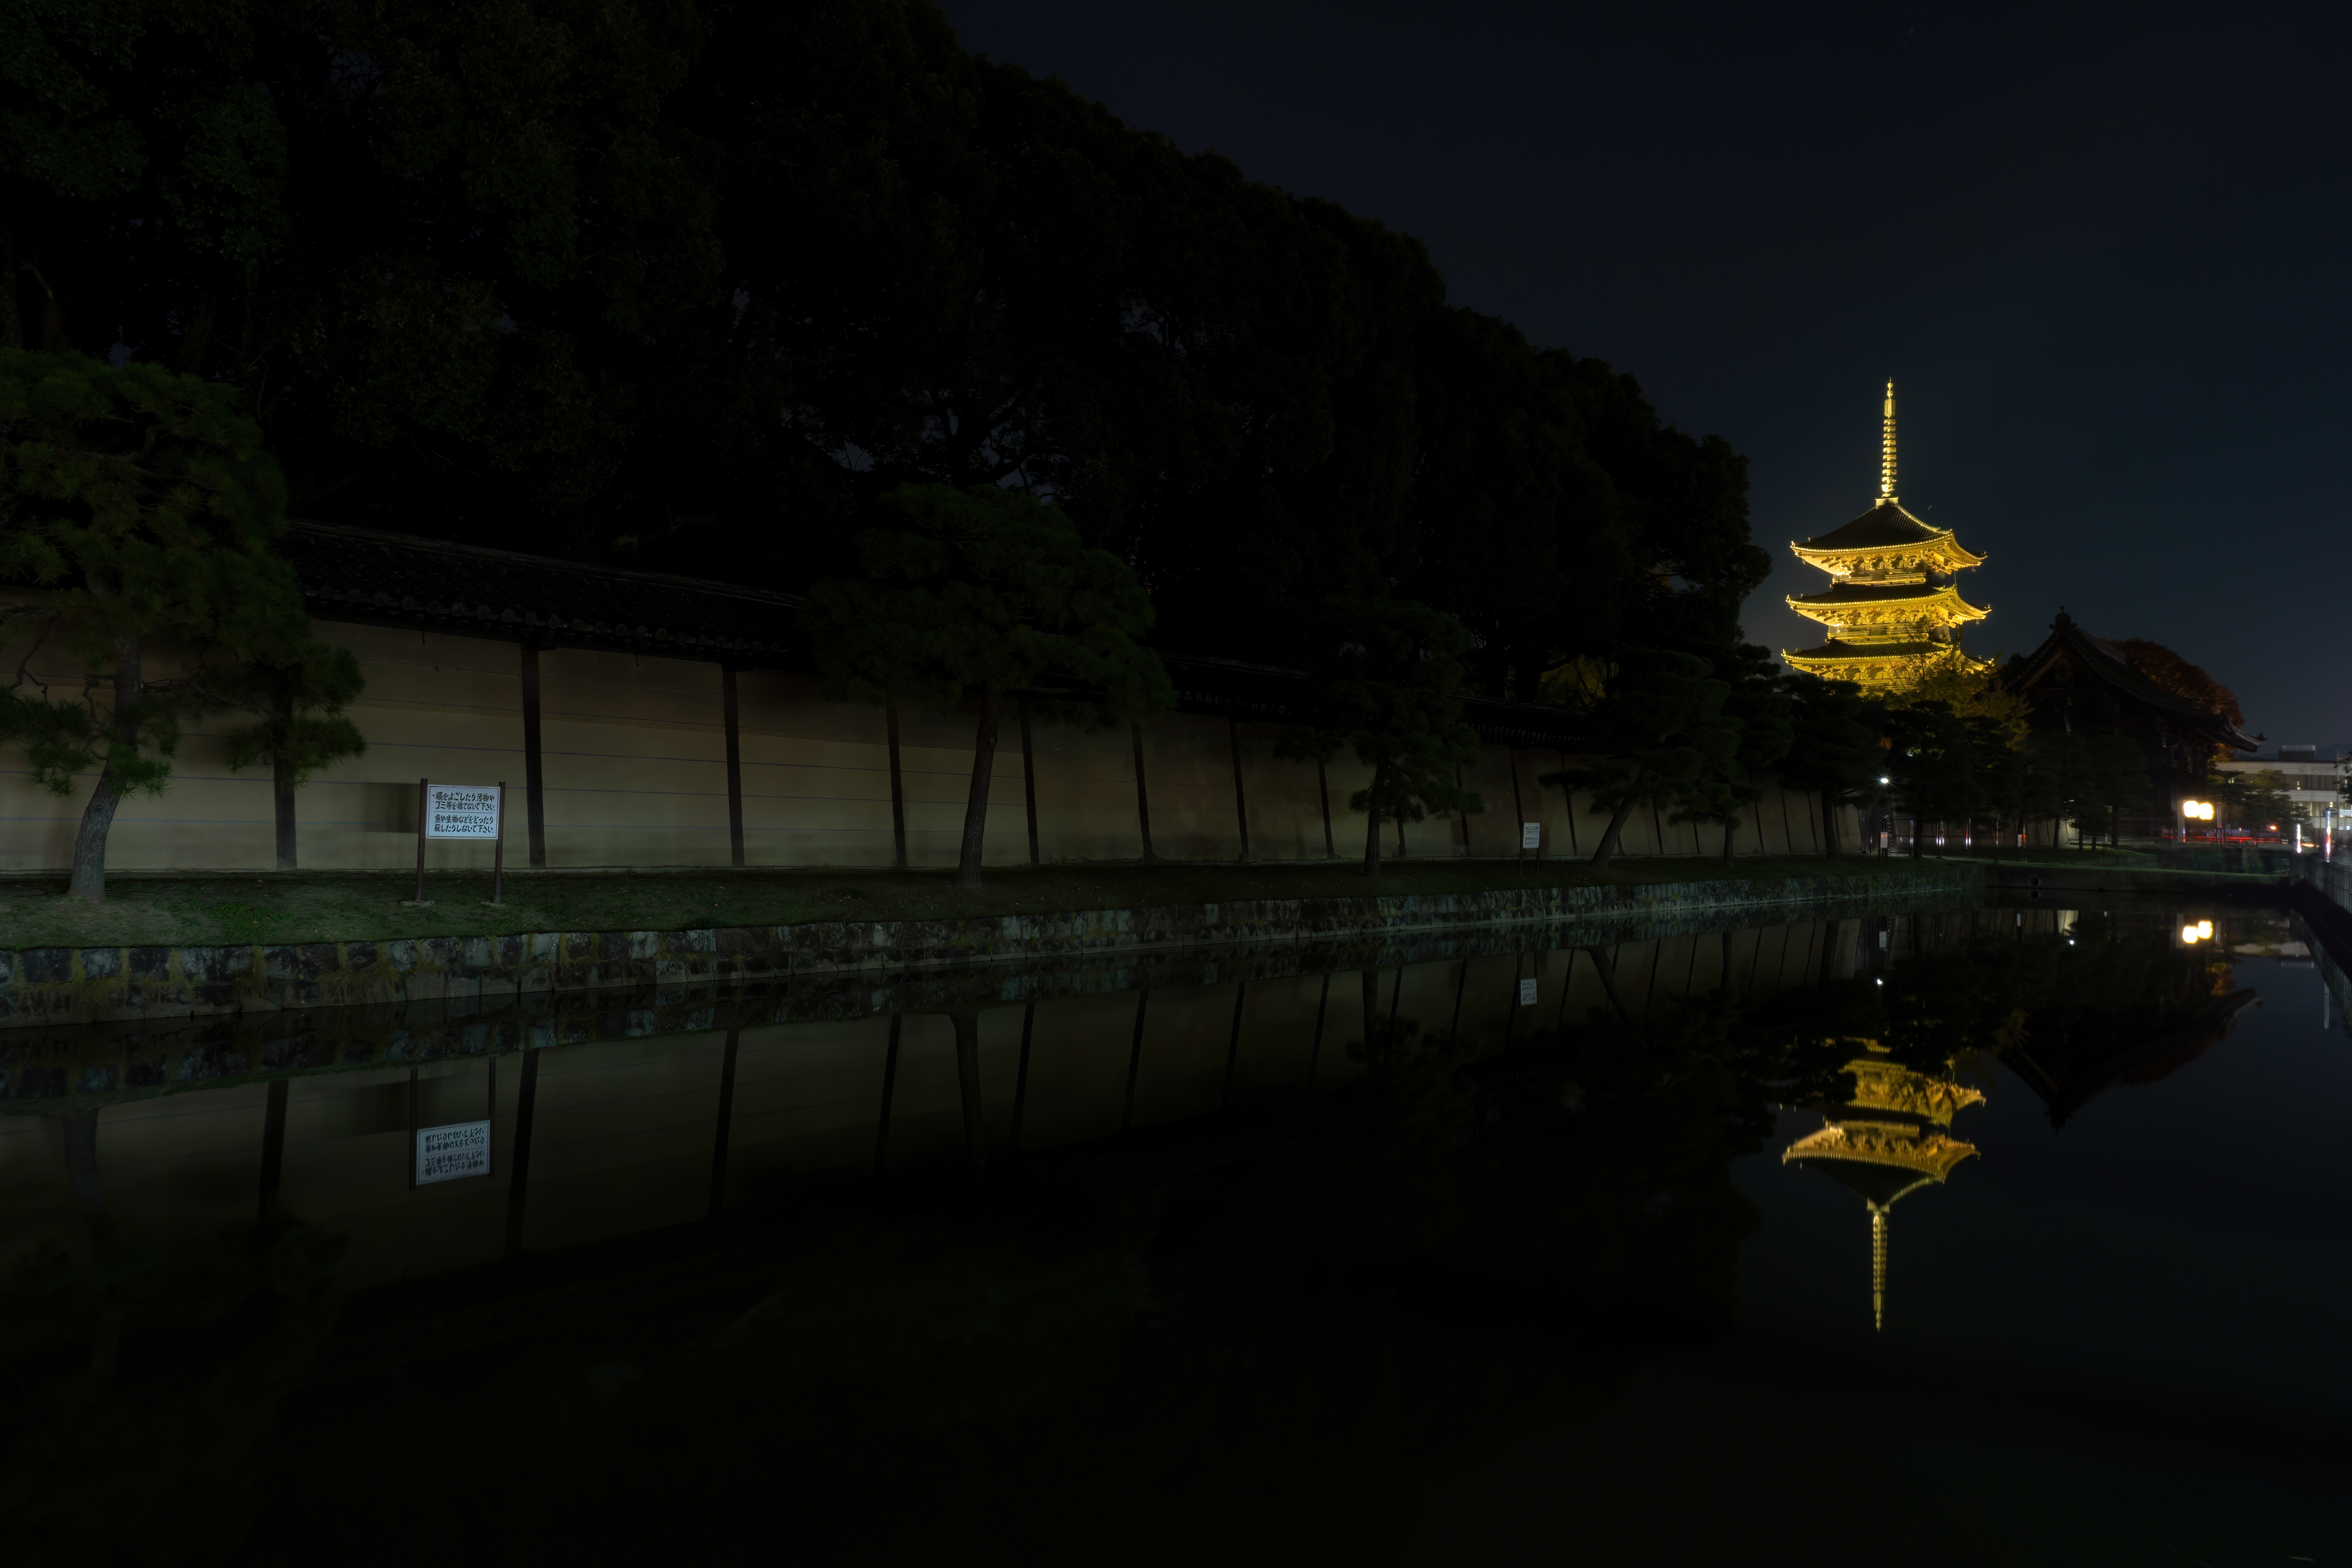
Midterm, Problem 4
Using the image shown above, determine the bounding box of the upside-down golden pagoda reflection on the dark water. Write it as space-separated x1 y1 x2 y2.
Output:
1780 1041 1985 1328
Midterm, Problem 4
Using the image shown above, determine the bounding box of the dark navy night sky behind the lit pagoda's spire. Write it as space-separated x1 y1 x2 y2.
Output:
946 0 2352 743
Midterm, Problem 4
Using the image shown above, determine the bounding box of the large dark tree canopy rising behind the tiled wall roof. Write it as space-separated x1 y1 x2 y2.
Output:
0 0 1766 698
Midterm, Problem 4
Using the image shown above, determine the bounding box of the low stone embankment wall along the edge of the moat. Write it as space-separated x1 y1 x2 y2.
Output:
0 863 1985 1030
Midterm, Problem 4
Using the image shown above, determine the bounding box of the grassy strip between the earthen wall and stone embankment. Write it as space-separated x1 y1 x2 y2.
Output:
0 856 1941 947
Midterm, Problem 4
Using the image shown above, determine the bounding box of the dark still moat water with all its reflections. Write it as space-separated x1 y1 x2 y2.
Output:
0 896 2352 1566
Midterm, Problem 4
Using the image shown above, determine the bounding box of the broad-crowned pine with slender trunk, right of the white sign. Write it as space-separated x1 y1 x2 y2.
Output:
804 484 1174 889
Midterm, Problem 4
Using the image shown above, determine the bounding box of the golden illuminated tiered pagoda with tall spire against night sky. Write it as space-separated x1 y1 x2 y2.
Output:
1780 381 1992 691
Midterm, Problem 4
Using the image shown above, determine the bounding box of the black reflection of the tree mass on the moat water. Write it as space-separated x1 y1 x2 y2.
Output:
9 926 2258 1563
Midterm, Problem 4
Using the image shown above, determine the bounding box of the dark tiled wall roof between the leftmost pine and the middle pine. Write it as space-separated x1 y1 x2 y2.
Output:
278 522 802 665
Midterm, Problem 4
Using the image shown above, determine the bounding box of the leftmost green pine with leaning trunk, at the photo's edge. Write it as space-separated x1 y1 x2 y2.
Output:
0 350 358 900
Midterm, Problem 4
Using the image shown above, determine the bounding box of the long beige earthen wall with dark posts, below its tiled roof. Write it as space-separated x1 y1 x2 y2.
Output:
0 623 1858 872
